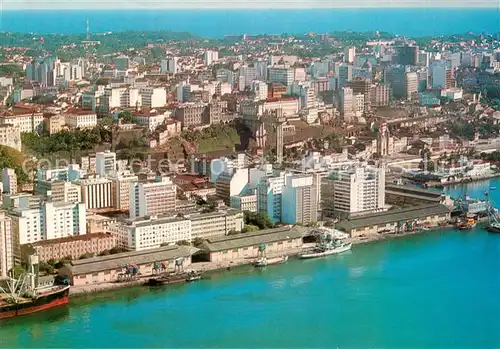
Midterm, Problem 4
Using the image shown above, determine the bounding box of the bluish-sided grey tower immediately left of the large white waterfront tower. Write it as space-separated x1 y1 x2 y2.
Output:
281 174 318 224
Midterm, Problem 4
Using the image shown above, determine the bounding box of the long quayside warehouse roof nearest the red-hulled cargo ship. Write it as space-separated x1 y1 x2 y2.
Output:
71 246 198 275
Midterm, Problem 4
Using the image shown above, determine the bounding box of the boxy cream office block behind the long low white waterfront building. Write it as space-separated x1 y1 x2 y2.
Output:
129 177 177 218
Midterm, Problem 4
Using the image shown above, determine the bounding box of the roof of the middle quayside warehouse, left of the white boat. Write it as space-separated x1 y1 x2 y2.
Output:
200 226 307 252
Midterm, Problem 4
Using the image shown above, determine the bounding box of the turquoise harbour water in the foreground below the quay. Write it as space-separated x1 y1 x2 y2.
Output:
0 181 500 348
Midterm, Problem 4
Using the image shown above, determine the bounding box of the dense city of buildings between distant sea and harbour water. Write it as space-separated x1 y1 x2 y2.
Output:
0 20 500 324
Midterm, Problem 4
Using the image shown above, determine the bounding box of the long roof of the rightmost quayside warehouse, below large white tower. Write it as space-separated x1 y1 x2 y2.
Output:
335 204 450 231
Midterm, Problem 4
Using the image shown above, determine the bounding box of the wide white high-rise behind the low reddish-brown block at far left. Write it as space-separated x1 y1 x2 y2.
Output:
10 197 87 245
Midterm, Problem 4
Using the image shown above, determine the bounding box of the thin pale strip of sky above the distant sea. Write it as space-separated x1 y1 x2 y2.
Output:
0 0 500 9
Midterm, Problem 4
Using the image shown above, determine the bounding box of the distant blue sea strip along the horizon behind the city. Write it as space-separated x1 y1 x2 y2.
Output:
0 8 500 37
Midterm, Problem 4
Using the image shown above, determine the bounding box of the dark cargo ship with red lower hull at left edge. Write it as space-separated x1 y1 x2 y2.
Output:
0 256 70 320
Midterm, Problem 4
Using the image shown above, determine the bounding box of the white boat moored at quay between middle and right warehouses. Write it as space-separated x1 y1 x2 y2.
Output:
299 229 352 259
